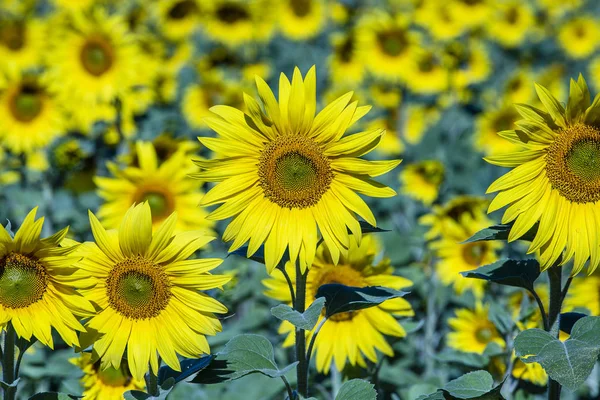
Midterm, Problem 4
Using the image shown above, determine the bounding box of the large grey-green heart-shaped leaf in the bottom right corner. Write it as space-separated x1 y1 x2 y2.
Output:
515 317 600 390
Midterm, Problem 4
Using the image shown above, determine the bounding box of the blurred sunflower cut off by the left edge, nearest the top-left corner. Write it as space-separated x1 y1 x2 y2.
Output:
0 17 46 70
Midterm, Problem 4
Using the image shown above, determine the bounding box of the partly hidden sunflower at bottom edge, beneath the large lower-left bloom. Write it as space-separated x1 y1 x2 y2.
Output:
70 353 146 400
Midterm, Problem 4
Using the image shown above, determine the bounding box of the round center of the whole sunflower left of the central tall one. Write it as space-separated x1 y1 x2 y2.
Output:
106 256 171 319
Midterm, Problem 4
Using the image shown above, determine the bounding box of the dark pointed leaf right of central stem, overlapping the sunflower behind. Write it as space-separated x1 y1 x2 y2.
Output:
316 283 407 318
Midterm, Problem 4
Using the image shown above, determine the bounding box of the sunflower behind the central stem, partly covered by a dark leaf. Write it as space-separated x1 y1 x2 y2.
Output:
263 235 414 374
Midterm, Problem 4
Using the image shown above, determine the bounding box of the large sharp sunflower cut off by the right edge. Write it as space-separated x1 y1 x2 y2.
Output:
486 76 600 275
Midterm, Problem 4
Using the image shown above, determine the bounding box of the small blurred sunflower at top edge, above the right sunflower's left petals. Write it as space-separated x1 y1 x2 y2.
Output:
486 0 535 48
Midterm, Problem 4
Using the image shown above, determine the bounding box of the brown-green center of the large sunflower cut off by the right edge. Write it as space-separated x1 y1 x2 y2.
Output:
546 124 600 203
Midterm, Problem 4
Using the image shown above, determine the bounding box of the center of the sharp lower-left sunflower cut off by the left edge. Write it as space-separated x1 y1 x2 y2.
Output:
0 253 48 308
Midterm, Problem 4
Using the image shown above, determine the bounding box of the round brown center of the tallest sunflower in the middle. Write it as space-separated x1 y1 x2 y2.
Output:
258 136 333 208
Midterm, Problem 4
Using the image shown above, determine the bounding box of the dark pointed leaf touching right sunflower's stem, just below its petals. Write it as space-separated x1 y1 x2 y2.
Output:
461 259 541 291
